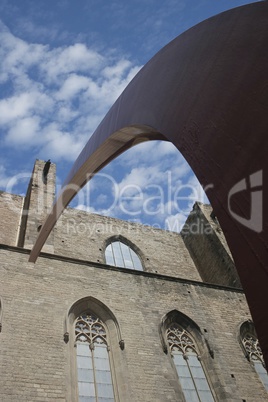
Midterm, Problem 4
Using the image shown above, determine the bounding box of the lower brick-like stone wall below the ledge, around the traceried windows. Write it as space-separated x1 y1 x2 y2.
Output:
0 246 267 402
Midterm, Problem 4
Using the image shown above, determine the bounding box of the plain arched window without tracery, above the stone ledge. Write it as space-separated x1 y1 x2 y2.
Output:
105 240 143 271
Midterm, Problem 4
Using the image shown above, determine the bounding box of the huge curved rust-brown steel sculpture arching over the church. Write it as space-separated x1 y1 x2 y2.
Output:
30 2 268 366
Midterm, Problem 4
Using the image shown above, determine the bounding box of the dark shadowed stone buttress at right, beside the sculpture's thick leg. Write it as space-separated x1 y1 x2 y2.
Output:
181 203 241 288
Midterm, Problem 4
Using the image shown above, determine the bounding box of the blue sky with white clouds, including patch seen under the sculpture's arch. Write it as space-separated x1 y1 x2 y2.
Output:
0 0 260 231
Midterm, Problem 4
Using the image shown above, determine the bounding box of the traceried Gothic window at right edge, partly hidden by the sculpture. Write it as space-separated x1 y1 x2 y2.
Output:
241 323 268 391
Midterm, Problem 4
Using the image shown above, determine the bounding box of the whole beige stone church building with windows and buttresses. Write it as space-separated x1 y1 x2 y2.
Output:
0 160 268 402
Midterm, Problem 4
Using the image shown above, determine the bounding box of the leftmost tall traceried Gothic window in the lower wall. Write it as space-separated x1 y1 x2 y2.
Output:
75 313 115 402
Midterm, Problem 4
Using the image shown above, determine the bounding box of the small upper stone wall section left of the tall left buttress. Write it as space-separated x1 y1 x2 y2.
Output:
0 191 24 246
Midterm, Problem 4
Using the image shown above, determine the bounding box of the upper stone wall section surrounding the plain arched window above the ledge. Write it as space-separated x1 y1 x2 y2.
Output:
54 208 201 280
